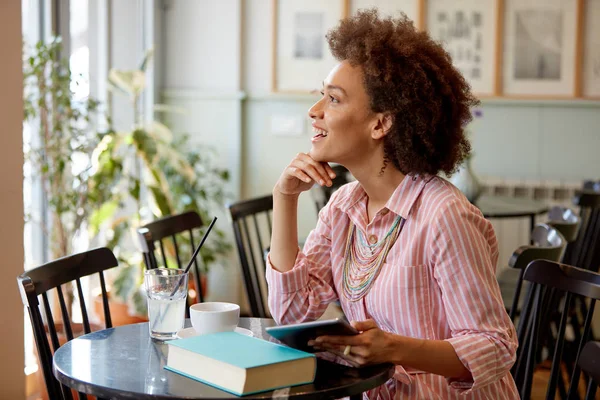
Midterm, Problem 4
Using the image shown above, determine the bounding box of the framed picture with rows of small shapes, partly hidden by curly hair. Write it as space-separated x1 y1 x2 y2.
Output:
425 0 500 96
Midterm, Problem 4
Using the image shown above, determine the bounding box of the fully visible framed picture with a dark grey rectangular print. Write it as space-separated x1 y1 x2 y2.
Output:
503 0 578 97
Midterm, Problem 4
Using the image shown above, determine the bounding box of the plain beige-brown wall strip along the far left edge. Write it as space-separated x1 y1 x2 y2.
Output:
0 1 25 399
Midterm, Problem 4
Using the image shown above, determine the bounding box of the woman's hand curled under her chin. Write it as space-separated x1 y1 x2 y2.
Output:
273 153 335 196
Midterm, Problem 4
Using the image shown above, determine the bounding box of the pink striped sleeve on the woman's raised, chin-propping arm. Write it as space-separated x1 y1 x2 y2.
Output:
266 206 338 324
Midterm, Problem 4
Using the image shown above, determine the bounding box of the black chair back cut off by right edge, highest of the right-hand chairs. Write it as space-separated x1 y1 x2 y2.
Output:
564 187 600 271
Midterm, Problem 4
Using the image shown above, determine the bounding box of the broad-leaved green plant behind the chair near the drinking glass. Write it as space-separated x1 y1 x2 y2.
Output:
90 53 230 315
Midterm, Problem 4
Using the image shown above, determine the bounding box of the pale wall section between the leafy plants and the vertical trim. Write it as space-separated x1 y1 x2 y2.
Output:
160 0 243 303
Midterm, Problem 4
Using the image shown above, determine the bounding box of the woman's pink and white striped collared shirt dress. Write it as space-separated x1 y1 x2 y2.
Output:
267 175 519 400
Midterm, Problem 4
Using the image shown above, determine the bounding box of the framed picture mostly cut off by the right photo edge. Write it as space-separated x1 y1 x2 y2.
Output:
582 0 600 98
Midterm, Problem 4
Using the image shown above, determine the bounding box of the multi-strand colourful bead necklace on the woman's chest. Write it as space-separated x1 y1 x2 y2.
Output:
342 216 406 301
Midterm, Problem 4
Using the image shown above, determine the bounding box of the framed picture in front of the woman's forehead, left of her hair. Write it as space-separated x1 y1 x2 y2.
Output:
272 0 349 93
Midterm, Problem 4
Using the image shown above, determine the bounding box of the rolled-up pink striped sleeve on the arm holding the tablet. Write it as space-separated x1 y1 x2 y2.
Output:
431 198 517 394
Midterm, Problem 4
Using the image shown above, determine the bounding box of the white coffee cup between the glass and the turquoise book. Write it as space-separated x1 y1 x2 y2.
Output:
190 302 240 335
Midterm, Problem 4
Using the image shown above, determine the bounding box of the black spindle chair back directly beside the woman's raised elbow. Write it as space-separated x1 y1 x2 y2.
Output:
228 196 273 318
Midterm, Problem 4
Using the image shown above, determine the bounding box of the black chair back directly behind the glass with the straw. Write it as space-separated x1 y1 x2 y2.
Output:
138 211 204 303
